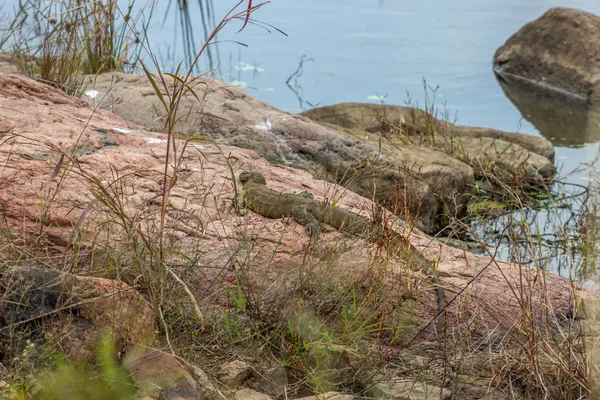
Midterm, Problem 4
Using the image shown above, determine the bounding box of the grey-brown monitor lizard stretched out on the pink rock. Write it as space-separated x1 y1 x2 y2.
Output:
233 170 444 324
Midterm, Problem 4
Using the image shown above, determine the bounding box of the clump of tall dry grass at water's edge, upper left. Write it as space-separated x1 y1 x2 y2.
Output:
0 0 152 96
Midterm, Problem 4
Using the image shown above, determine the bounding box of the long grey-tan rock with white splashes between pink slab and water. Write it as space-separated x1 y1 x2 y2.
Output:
78 73 554 233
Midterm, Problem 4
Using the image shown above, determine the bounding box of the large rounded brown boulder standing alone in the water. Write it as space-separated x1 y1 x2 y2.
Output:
494 8 600 102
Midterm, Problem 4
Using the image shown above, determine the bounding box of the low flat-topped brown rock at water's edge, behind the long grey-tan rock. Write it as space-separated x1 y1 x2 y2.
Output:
303 103 554 185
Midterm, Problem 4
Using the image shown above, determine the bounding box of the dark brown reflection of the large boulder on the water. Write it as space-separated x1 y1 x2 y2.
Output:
496 71 600 147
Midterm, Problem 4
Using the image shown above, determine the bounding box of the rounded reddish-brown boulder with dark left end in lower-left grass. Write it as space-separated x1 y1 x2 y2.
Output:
0 267 154 361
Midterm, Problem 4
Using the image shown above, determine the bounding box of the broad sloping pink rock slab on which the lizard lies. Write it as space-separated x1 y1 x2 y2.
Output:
0 75 587 398
